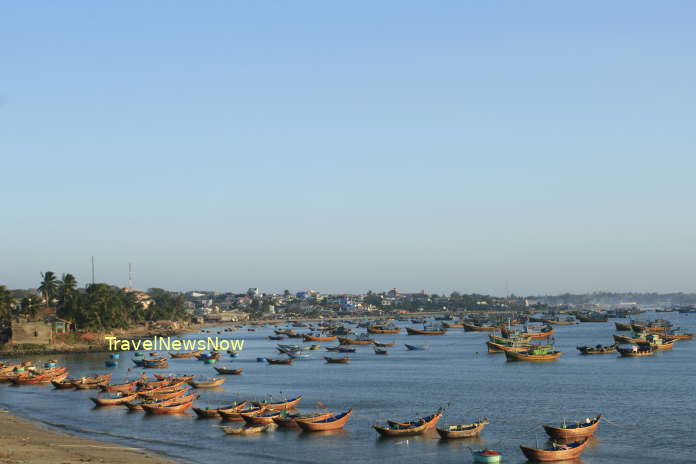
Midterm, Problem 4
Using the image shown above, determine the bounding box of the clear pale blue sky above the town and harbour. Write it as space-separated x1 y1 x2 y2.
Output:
0 0 696 295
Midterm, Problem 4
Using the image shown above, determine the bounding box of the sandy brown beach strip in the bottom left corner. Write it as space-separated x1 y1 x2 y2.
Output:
0 410 175 464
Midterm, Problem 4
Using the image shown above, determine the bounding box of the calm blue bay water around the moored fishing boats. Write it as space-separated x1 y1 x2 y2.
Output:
0 313 696 464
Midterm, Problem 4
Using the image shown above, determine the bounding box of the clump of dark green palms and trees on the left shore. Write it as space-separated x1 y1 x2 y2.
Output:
0 271 189 330
